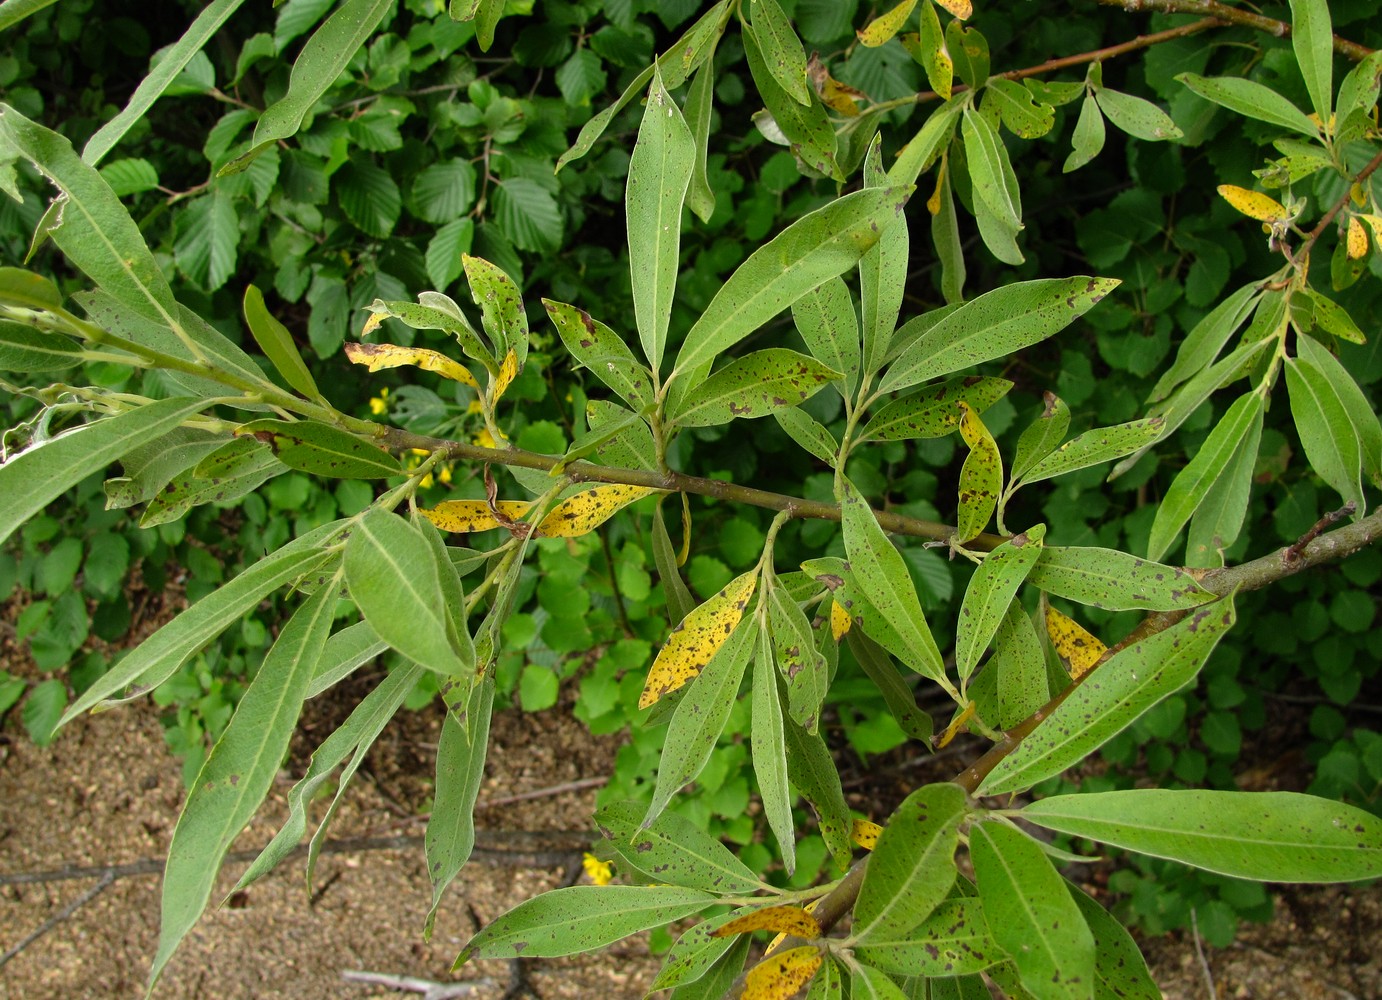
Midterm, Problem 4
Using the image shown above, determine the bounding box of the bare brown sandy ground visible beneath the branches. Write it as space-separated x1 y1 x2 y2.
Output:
0 632 1382 1000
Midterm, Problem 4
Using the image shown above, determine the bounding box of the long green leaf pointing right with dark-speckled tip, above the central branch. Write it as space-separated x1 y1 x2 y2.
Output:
879 276 1119 392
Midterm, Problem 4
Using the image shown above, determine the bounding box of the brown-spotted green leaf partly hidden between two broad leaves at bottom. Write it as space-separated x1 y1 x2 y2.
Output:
857 900 1005 977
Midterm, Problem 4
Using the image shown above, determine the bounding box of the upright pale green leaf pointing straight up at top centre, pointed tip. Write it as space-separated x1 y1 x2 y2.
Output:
625 70 697 372
